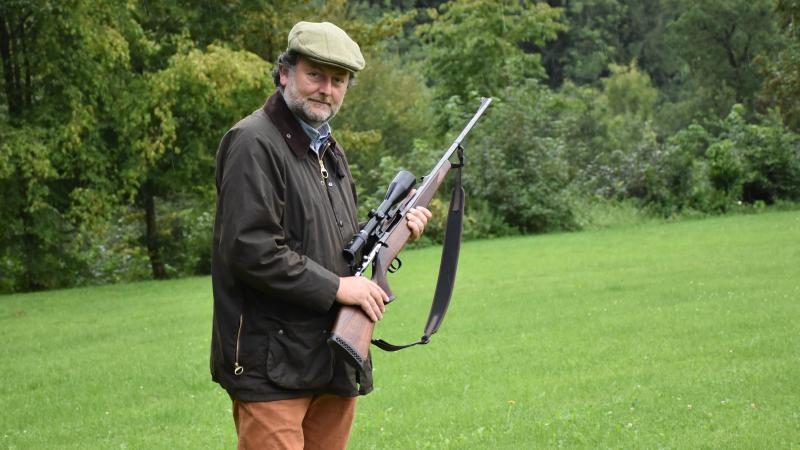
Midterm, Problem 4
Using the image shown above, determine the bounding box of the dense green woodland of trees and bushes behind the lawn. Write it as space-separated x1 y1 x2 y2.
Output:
0 0 800 292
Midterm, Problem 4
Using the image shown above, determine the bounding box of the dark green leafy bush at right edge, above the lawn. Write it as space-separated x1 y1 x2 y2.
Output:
647 105 800 212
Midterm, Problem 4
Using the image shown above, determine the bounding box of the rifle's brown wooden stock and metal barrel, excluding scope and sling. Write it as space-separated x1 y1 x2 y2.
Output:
328 99 491 370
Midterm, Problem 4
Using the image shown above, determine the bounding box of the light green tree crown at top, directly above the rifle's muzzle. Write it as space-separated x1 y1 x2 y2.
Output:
417 0 564 115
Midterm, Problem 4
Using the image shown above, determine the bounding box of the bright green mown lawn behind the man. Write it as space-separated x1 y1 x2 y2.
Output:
0 212 800 449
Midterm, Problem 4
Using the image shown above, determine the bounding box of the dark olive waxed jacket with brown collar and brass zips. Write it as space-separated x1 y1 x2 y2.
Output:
211 91 372 401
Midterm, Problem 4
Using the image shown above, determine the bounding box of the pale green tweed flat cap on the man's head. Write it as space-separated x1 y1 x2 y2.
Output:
286 22 365 72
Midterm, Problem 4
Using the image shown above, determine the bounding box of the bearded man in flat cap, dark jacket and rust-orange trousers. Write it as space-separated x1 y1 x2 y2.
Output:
211 22 430 449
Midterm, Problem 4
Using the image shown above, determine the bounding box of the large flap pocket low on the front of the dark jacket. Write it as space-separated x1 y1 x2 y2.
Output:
267 318 334 390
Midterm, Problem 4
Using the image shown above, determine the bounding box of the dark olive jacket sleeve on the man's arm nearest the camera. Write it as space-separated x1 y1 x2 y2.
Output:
217 129 339 313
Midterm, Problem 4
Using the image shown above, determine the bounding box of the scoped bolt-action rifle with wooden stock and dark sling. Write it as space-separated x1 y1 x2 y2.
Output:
328 98 492 370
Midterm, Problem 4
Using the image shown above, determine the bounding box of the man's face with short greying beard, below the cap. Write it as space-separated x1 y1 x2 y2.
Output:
280 57 350 127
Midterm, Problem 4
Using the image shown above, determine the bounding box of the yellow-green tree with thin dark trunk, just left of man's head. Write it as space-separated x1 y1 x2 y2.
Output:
119 45 272 278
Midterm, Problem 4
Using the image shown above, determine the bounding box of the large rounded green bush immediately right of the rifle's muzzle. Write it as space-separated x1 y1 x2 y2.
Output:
465 81 577 232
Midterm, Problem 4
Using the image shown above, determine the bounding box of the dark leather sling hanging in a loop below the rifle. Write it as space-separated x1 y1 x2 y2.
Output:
372 145 464 352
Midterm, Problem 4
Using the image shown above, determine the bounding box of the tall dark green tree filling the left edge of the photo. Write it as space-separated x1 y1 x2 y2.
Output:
0 0 138 290
